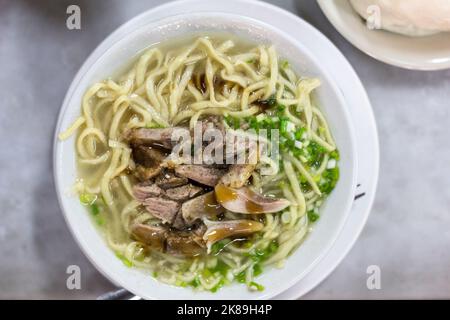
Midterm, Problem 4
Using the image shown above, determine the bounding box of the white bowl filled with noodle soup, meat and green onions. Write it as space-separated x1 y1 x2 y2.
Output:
54 12 357 299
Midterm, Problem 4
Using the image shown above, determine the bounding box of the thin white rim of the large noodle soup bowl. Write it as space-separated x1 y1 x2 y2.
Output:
53 10 357 299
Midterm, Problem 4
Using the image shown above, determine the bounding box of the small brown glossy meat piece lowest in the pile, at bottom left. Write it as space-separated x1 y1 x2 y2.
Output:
167 233 206 256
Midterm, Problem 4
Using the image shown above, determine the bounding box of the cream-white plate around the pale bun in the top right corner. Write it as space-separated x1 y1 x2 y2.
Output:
318 0 450 70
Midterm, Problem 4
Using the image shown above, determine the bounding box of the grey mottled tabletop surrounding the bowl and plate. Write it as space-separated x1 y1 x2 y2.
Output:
0 0 450 299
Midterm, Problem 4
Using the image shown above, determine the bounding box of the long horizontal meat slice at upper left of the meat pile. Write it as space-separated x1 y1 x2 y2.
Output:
124 127 187 150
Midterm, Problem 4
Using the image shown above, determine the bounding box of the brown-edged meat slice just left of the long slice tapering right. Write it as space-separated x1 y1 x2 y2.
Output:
181 191 225 225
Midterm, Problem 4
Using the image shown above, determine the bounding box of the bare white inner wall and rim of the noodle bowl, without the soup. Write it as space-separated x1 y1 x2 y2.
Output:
54 12 357 299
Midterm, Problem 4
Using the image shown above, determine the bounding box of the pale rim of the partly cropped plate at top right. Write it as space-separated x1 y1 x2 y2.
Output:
317 0 450 71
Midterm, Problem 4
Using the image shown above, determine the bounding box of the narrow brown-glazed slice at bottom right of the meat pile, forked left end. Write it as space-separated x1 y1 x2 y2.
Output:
203 220 264 248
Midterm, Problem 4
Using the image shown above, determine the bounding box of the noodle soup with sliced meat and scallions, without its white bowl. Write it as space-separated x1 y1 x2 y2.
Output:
60 34 339 292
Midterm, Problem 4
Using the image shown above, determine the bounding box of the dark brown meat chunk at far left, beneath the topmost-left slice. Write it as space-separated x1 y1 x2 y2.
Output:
133 146 166 181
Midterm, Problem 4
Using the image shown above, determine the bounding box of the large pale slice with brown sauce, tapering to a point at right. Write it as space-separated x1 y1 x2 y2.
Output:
215 184 290 214
